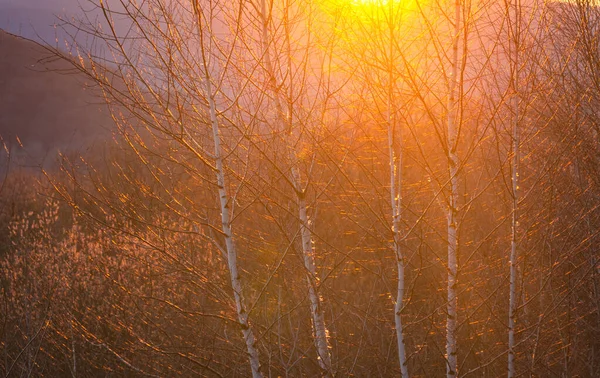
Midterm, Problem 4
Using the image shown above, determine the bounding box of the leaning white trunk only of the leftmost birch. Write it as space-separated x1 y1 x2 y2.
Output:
205 66 263 378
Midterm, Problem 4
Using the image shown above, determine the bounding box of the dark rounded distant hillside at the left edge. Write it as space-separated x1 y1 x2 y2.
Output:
0 30 112 165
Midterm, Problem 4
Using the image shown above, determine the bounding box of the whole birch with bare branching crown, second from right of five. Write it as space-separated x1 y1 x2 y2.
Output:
402 0 496 377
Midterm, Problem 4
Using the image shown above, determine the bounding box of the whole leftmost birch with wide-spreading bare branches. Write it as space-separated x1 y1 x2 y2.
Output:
51 0 262 377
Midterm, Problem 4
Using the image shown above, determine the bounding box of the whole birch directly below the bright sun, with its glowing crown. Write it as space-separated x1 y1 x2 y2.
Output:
332 1 418 377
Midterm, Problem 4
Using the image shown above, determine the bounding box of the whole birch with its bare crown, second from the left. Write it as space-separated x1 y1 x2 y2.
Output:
250 0 334 376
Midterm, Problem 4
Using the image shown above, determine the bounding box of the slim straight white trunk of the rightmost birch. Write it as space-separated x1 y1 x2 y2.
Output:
508 0 520 378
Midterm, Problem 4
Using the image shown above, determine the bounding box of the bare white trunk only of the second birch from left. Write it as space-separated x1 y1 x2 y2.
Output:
261 0 333 377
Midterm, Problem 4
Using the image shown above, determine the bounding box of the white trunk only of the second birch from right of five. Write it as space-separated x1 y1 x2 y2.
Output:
446 0 461 378
